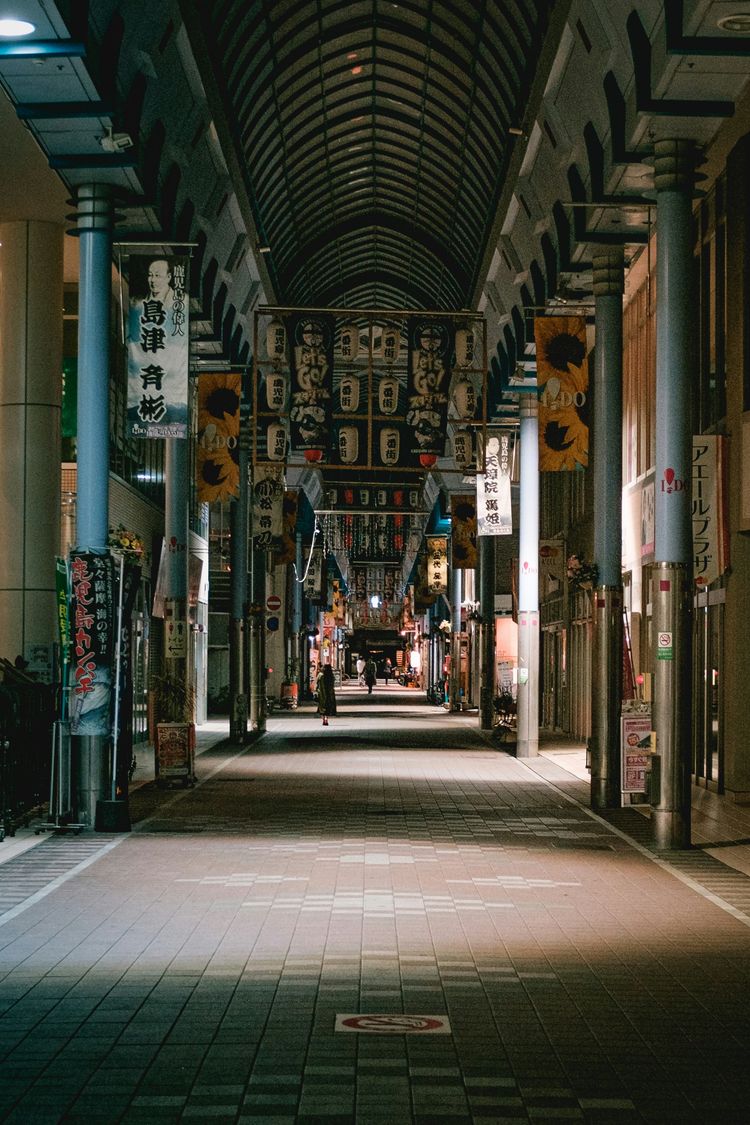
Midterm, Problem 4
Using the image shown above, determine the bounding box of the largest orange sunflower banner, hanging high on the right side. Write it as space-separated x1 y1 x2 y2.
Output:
534 316 589 471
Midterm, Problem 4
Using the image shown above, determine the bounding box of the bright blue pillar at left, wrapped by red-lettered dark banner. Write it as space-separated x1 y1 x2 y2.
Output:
72 183 112 826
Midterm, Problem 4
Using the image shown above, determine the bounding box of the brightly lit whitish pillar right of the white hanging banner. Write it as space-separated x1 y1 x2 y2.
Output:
516 393 539 758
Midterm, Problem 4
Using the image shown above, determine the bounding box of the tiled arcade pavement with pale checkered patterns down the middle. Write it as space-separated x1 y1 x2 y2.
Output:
0 690 750 1125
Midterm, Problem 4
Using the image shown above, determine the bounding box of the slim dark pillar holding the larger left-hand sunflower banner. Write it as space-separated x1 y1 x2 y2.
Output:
229 438 249 743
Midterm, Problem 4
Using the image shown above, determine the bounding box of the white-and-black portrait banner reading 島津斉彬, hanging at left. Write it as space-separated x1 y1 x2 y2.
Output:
127 254 190 438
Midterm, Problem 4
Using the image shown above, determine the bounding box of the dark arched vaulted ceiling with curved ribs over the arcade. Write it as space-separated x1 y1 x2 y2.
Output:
201 0 553 309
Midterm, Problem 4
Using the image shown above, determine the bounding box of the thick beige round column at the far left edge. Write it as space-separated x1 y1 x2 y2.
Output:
0 222 63 660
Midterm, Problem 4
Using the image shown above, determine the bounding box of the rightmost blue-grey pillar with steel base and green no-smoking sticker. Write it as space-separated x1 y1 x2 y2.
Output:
652 141 697 848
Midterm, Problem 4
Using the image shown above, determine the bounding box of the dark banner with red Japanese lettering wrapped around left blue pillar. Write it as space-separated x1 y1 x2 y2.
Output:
70 551 114 735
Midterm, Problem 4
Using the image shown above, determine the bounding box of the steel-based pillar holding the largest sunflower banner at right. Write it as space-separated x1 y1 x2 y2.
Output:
590 246 624 809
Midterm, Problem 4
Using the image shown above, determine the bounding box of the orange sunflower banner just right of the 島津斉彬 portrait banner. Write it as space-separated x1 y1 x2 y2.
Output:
196 372 242 504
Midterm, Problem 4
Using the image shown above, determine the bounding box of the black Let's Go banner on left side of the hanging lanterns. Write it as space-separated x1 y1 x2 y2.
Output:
289 314 334 452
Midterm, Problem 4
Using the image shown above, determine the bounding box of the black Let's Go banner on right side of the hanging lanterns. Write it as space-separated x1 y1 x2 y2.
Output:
406 317 453 464
